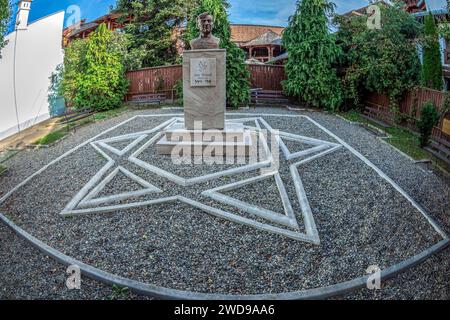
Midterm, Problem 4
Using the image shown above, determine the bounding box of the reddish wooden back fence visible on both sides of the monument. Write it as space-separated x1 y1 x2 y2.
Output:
126 65 285 100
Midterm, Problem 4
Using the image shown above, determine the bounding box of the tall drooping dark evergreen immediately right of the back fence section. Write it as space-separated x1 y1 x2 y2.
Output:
283 0 342 110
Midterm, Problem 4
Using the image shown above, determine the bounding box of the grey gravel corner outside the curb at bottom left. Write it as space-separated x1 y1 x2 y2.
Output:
0 223 152 300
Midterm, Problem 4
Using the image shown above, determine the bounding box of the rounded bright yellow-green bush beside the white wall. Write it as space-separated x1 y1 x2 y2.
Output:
61 24 128 111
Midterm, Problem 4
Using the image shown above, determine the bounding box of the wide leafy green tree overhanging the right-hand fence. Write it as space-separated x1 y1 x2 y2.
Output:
335 2 422 111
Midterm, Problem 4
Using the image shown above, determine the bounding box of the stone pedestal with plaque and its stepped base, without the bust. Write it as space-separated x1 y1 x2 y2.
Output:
156 49 257 160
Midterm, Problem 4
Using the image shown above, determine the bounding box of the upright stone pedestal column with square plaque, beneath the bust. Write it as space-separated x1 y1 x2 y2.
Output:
183 49 226 130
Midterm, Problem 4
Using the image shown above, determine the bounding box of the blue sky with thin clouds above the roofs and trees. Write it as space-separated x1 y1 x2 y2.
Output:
7 0 445 32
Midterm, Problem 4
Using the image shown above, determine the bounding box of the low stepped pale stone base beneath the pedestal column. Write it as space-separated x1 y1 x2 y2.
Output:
156 123 257 157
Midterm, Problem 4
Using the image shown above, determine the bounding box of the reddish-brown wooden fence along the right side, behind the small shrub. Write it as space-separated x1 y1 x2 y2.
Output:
365 88 450 144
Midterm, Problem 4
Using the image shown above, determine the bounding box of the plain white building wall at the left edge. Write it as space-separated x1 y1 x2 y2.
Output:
0 12 64 140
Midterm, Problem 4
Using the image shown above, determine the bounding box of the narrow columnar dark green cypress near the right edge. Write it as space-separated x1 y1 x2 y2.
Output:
422 13 443 90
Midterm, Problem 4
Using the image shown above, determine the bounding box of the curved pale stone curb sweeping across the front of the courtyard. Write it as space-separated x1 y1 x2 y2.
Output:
0 213 450 300
